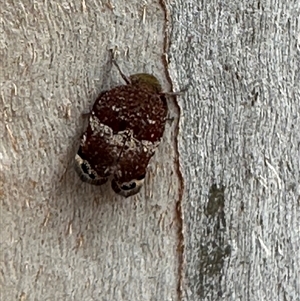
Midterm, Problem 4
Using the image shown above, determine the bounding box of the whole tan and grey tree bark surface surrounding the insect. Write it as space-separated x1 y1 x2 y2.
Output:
0 0 300 301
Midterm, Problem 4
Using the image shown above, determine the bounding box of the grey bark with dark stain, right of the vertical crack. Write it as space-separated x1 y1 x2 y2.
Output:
169 0 300 301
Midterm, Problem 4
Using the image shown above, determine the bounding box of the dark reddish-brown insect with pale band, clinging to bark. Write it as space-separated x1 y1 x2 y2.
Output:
75 60 168 197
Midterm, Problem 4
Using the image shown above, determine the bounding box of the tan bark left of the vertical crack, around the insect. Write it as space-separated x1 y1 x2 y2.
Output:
0 0 180 300
